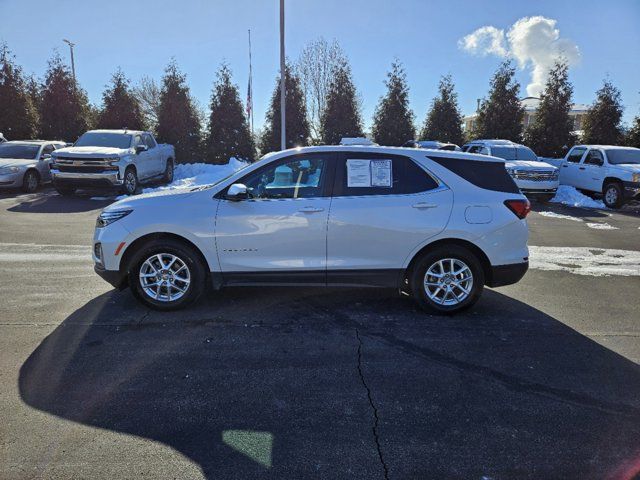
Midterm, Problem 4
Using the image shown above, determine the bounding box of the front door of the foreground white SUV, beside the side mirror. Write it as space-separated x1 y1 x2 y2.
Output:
215 152 335 285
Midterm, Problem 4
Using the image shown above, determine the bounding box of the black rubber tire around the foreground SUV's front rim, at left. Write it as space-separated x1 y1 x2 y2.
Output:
128 239 207 311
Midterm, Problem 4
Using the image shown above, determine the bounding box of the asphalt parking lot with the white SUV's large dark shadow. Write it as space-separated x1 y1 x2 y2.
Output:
0 189 640 480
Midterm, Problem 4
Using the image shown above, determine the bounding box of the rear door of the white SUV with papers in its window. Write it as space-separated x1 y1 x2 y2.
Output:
327 152 453 286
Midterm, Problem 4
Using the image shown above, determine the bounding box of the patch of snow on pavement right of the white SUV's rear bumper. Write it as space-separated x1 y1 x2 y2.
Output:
529 246 640 277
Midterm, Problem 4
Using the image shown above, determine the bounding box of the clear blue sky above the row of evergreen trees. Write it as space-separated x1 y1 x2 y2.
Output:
0 0 640 131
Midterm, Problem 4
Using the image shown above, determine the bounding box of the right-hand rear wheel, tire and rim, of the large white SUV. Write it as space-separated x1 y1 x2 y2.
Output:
411 245 484 315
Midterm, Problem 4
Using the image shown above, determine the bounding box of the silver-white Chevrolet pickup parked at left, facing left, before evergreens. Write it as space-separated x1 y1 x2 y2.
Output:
51 130 175 195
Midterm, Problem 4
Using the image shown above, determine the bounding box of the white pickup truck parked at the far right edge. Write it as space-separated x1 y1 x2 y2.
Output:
547 145 640 208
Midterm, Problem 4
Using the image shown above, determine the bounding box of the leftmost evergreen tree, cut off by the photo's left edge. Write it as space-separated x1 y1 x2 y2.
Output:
0 44 38 140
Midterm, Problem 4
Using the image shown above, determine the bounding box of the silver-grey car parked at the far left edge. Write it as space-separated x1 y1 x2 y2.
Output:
0 140 65 193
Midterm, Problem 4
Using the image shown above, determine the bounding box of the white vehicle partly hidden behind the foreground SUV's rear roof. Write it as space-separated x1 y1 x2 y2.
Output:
462 140 560 202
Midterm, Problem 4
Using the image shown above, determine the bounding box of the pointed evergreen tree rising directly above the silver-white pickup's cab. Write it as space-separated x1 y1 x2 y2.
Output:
97 69 144 130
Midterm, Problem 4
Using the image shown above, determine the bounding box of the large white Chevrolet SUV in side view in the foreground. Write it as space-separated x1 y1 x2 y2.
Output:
93 146 529 313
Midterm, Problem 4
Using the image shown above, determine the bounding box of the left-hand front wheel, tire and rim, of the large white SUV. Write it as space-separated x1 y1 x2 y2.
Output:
129 239 206 310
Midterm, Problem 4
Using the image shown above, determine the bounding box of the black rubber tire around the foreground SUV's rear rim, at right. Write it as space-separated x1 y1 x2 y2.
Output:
410 245 484 315
